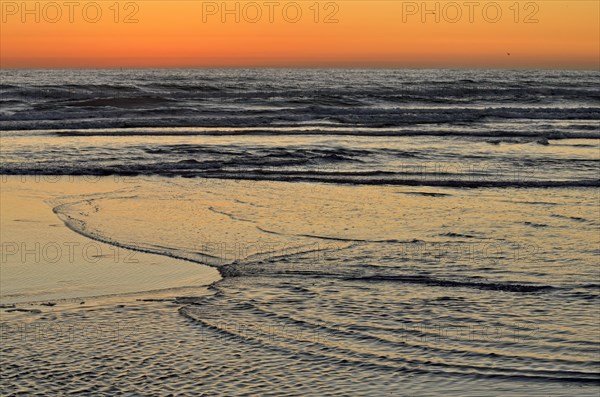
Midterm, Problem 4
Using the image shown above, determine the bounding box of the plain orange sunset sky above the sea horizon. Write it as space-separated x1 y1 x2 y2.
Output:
0 0 600 69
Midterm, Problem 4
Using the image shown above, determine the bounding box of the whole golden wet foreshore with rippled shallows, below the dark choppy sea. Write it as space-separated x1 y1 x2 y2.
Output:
1 177 597 396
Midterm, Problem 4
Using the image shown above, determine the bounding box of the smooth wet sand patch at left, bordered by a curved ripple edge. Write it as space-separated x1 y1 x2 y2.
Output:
0 176 222 305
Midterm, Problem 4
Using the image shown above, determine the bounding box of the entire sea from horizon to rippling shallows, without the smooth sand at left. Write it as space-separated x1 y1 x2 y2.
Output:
0 70 600 395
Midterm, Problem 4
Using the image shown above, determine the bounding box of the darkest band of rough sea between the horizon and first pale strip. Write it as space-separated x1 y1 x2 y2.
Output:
2 69 600 130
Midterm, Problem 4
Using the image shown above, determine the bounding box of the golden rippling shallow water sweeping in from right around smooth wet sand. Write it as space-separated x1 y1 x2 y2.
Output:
28 178 600 393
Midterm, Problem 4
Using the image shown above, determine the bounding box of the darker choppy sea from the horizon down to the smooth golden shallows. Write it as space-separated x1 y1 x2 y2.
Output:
0 70 600 187
